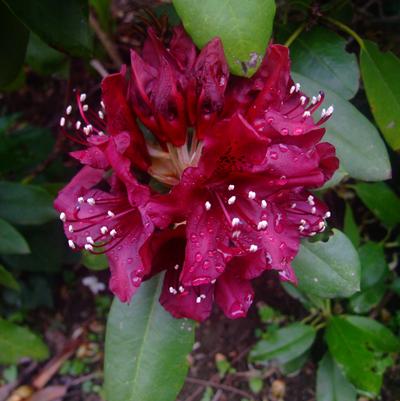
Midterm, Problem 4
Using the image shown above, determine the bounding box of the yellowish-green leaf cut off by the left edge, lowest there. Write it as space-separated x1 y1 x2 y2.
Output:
0 320 49 364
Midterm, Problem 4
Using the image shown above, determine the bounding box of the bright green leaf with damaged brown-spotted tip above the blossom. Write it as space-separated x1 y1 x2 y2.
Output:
173 0 275 76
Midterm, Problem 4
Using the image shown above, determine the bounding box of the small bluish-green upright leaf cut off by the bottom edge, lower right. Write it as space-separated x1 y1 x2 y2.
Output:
317 353 357 401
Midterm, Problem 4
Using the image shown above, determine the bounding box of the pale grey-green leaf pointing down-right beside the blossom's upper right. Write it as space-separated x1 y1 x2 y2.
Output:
292 70 391 181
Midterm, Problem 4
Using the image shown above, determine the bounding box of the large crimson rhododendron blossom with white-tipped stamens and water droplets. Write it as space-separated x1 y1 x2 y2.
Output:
55 27 338 320
